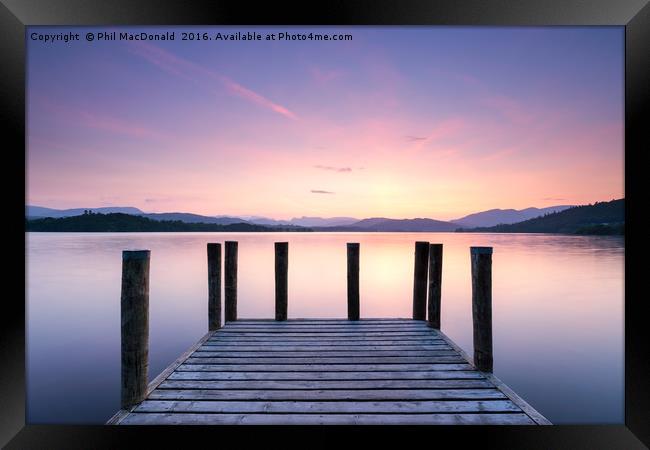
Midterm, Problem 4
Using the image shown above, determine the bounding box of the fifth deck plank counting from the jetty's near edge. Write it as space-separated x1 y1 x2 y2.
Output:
168 370 484 381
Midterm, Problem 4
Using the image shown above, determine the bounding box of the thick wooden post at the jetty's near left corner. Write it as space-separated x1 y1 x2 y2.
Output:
120 250 150 409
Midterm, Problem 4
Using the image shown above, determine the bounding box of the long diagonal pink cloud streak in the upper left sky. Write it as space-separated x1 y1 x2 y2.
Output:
131 42 298 120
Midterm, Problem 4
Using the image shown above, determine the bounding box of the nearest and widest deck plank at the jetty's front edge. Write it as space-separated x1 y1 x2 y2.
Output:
122 413 535 425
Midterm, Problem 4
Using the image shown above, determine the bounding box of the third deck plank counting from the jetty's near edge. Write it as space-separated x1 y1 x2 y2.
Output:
149 388 507 401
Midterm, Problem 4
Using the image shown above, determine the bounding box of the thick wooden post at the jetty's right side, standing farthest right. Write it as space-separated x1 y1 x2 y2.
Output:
470 247 492 372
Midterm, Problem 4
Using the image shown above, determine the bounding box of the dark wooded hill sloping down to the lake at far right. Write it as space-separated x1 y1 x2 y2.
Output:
456 199 625 234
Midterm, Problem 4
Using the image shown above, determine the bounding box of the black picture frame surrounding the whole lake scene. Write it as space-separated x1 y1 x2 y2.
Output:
0 0 650 449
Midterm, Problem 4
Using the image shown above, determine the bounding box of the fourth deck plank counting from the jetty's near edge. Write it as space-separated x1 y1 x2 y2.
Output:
158 379 493 390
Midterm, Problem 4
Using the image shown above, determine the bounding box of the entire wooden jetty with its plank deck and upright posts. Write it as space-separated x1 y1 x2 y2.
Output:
108 243 550 425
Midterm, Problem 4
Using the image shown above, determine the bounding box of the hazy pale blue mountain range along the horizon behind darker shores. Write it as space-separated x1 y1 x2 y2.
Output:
25 205 600 232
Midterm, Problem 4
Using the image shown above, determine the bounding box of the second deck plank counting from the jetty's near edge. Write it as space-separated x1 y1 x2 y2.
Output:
134 400 521 414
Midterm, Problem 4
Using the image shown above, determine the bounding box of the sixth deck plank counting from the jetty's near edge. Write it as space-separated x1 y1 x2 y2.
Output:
176 362 472 372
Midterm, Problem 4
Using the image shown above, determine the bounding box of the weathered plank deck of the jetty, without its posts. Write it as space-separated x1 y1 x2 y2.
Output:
108 319 550 425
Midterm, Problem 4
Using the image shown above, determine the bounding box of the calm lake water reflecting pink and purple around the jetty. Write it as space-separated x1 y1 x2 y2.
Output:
26 233 625 424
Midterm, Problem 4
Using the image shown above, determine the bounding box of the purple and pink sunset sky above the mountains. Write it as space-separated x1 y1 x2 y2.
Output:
26 27 624 220
